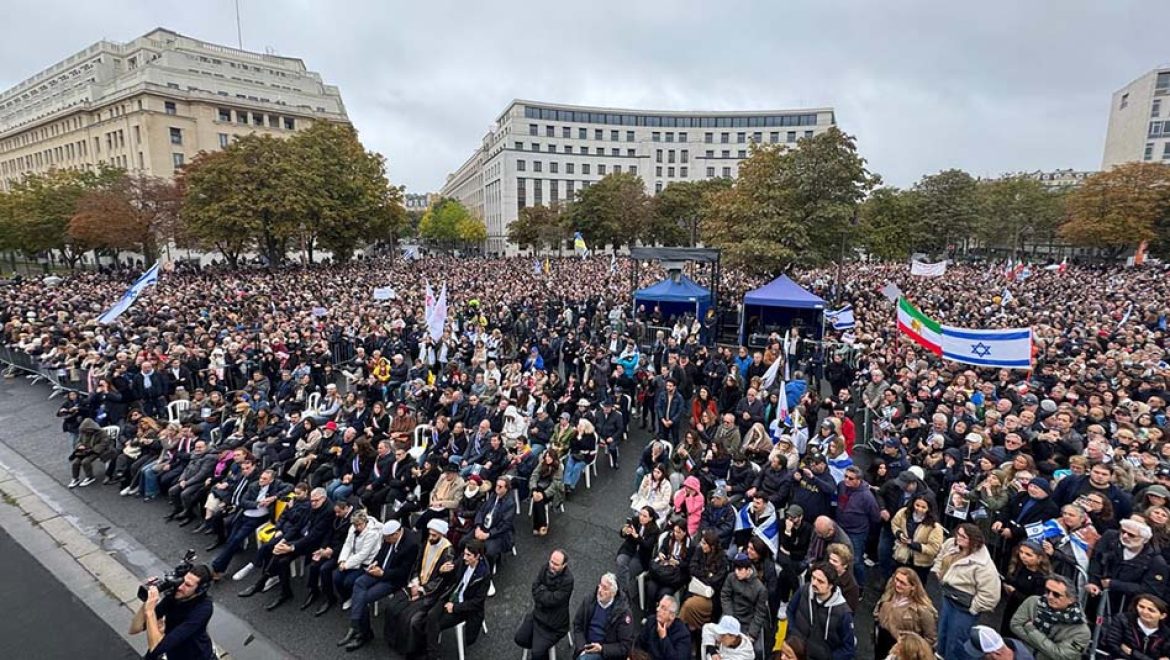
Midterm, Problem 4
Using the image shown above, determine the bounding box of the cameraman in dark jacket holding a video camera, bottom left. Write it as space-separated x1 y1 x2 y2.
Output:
130 564 215 660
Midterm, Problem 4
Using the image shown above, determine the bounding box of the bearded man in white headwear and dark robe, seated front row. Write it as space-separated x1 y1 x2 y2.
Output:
383 518 455 653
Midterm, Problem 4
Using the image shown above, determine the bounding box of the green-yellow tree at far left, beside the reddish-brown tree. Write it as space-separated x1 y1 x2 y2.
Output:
11 165 124 268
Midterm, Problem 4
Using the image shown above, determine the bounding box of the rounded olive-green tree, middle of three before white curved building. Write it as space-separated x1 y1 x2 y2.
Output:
566 172 651 247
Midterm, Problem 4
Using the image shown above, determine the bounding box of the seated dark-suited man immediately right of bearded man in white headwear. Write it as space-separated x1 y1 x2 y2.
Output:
407 538 491 660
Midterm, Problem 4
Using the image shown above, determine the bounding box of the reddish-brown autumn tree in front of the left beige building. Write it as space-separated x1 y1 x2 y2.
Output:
69 174 180 263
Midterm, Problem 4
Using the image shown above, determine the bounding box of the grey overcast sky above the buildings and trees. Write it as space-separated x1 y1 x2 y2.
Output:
0 0 1170 192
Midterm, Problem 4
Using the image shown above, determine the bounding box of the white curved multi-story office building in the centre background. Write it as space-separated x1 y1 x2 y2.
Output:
442 99 835 254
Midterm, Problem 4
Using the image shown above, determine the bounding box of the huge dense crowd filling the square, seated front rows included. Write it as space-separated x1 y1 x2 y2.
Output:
0 257 1170 660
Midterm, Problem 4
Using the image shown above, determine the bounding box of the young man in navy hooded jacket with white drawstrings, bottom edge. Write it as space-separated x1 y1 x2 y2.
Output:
781 562 856 660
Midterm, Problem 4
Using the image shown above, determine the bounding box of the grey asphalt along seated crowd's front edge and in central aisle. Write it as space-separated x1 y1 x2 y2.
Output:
0 378 878 660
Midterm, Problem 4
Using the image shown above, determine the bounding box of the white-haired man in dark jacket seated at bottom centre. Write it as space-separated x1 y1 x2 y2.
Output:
573 573 636 660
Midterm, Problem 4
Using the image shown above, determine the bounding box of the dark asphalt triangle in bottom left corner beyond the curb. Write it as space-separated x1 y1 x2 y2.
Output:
0 521 140 660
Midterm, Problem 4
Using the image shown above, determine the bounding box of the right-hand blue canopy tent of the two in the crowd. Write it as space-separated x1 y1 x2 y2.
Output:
739 275 825 345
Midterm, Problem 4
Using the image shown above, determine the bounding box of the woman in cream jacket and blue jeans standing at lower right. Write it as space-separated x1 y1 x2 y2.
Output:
934 523 1003 658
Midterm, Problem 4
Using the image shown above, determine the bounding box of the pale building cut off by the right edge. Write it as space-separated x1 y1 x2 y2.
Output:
1101 66 1170 170
